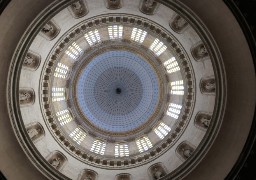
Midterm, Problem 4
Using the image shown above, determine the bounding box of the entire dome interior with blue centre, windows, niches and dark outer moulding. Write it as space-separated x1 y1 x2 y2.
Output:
9 0 225 179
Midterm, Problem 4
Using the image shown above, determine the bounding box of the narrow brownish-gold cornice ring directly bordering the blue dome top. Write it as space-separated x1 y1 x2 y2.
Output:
70 44 164 139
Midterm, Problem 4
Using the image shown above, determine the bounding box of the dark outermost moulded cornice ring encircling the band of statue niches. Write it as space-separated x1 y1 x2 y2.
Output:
8 1 225 179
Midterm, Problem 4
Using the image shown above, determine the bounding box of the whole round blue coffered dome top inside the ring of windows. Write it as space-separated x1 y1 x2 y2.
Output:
76 50 159 133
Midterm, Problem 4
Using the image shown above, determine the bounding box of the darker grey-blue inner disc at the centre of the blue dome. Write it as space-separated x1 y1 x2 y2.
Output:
94 67 143 115
